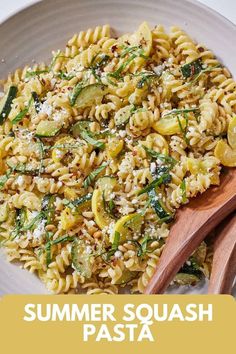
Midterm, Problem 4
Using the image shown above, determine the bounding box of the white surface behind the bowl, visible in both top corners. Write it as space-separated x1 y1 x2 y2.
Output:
0 0 236 24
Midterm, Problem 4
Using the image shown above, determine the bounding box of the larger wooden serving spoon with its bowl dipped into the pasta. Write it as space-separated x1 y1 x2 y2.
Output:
145 169 236 294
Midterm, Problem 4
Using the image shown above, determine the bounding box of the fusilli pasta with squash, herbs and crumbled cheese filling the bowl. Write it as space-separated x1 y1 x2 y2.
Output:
0 22 236 294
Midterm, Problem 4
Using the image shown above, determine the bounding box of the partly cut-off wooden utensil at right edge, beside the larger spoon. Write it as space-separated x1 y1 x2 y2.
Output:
208 213 236 294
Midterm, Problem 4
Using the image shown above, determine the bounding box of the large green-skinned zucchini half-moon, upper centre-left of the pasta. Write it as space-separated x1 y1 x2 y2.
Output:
75 84 107 108
